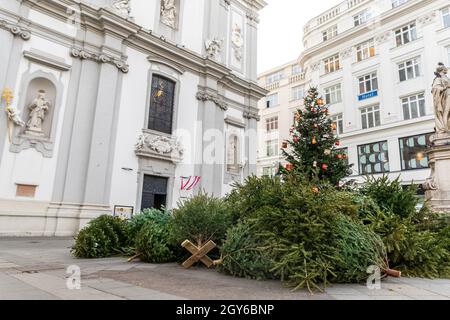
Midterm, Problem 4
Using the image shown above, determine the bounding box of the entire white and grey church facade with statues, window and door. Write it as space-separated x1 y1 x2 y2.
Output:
0 0 266 236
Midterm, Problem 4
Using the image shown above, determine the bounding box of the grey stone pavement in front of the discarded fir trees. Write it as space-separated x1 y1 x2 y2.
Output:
0 238 450 300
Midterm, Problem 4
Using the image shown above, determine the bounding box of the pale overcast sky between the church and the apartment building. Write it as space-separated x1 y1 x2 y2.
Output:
258 0 342 73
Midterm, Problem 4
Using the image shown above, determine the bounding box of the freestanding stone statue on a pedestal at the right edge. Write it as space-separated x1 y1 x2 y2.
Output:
432 63 450 133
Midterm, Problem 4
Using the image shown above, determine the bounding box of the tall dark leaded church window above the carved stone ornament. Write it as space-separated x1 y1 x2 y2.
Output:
148 75 175 134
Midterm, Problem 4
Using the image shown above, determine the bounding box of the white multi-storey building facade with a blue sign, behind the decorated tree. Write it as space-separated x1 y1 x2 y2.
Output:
258 0 450 184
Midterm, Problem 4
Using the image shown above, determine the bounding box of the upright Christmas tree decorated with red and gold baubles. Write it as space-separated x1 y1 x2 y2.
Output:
280 88 351 185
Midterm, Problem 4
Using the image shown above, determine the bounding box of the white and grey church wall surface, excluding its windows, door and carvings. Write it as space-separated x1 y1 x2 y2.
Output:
0 0 265 236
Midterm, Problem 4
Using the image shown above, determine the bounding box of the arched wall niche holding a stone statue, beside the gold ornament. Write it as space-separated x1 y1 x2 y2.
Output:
10 71 63 158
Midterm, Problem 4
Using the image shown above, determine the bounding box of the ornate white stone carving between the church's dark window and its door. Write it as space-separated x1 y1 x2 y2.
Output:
135 132 184 162
